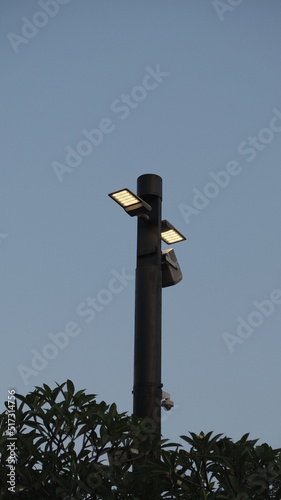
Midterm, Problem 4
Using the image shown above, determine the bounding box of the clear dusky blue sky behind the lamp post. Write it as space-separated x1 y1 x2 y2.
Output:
0 0 281 447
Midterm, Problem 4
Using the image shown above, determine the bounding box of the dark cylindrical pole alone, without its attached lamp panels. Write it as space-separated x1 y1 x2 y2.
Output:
133 174 162 438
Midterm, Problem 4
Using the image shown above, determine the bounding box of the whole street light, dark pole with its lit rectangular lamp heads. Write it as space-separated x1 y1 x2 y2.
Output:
109 174 186 439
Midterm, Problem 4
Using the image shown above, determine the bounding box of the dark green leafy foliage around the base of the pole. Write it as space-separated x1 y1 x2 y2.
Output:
0 380 281 500
